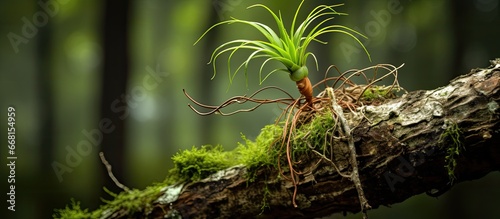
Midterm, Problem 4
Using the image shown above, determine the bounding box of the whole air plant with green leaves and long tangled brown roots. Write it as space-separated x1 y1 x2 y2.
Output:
191 0 378 213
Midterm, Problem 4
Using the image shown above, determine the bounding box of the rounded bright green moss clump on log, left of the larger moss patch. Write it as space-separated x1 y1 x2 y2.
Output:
170 145 237 181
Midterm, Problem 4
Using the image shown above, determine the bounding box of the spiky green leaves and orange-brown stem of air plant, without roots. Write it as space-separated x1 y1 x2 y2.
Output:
195 0 370 106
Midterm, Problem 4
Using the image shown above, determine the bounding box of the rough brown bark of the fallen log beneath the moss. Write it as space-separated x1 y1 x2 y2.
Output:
136 59 500 218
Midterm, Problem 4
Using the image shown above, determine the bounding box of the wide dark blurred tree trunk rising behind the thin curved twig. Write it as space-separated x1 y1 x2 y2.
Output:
100 0 134 198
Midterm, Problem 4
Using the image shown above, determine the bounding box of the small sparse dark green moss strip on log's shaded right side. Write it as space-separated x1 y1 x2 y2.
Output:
439 122 464 184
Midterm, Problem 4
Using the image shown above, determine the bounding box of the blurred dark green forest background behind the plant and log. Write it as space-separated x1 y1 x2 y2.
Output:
0 0 500 219
